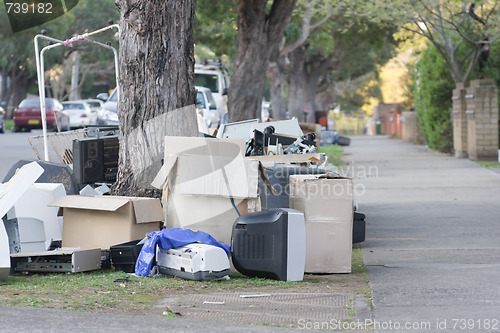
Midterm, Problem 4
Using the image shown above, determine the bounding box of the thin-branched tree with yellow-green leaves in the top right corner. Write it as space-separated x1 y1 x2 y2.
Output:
358 0 500 82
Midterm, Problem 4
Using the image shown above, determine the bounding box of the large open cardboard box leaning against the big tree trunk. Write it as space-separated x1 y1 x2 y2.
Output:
152 137 260 244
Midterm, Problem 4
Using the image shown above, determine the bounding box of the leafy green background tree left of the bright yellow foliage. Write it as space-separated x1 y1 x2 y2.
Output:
288 14 392 122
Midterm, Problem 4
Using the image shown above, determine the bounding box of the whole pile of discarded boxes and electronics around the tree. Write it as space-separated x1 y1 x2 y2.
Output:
0 119 365 281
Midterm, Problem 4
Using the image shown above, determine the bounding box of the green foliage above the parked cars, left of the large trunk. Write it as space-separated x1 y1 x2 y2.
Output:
0 0 119 105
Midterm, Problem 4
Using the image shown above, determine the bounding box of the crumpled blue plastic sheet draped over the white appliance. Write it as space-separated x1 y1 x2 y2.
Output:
135 228 229 276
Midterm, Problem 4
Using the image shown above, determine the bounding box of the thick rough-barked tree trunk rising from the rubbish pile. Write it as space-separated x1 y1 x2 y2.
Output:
113 0 198 196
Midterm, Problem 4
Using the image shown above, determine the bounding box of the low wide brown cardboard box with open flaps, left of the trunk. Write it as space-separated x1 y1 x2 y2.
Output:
50 195 163 249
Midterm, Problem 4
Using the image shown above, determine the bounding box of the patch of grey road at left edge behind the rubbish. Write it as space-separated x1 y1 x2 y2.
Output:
0 130 42 182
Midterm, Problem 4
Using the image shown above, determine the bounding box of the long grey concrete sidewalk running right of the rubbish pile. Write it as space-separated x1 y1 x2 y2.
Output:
344 136 500 332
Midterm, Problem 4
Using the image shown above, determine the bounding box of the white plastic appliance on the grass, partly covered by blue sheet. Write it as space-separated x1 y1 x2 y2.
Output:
156 243 230 281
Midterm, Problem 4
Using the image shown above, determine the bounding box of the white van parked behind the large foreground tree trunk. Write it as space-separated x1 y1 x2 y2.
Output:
194 64 229 119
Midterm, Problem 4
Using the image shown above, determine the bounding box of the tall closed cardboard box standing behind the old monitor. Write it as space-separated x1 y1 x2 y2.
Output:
290 173 353 273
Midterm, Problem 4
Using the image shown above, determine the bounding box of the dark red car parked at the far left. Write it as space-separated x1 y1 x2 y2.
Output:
14 98 69 132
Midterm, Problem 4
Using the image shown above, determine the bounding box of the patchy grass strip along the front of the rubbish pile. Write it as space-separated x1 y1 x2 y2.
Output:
0 270 318 313
